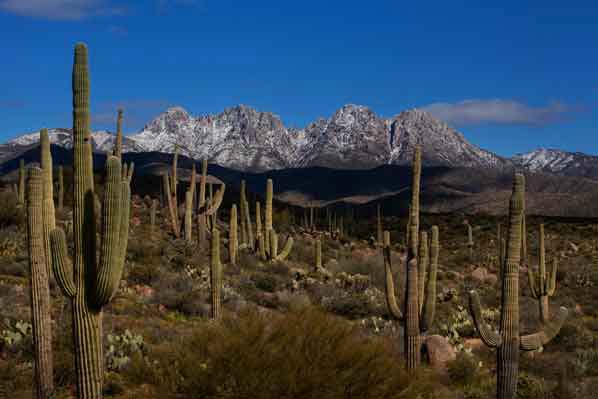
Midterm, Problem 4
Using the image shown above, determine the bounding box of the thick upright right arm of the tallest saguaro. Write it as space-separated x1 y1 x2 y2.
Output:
89 156 126 309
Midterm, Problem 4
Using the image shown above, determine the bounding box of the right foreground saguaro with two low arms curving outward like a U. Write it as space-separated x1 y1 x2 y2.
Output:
469 174 567 399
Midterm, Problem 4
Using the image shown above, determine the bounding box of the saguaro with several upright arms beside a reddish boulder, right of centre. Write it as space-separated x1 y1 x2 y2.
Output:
382 147 440 372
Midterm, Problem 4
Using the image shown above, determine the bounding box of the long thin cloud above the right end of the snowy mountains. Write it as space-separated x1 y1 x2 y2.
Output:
421 99 580 126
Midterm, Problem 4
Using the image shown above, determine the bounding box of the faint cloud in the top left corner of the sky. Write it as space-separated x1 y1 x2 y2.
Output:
0 0 125 21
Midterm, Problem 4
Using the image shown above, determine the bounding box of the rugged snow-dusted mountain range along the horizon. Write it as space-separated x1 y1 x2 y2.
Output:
0 104 598 179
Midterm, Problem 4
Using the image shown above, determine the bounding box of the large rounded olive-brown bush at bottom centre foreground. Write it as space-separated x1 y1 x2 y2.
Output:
125 309 441 399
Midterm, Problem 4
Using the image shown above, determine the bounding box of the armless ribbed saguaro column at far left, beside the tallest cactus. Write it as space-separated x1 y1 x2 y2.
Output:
26 168 54 399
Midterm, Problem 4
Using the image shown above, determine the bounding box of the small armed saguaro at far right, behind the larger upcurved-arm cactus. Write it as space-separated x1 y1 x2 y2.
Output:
527 224 558 324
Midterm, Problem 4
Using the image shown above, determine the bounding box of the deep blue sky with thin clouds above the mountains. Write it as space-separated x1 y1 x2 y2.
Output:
0 0 598 156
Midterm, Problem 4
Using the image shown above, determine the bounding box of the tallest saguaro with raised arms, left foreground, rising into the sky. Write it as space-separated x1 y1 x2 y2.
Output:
51 44 131 399
